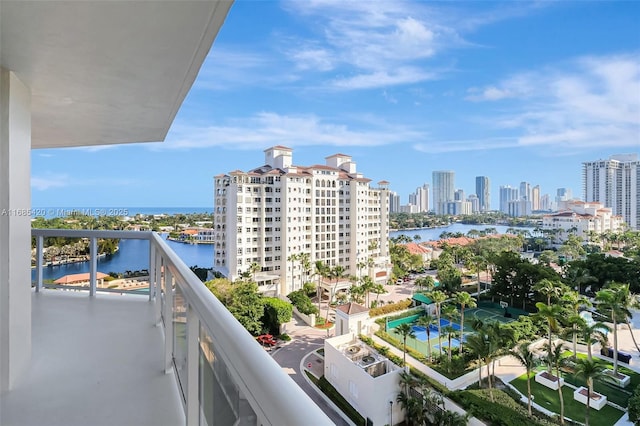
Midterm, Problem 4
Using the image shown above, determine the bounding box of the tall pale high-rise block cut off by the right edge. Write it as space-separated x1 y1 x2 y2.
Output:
582 154 640 229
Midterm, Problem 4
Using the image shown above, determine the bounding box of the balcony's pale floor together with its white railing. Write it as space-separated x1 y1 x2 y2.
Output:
0 230 332 426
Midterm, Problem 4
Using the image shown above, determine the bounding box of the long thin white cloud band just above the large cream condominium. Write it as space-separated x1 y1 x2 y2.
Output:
159 112 425 149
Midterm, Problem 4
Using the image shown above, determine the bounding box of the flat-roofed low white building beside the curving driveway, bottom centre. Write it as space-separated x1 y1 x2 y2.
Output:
324 334 404 426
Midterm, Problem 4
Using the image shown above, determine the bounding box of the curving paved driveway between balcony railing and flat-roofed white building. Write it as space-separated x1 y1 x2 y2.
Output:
273 320 348 426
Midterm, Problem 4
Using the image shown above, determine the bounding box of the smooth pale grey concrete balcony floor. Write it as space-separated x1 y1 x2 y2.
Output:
0 290 185 426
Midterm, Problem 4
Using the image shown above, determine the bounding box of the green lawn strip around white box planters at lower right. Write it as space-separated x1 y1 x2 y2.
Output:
511 374 624 425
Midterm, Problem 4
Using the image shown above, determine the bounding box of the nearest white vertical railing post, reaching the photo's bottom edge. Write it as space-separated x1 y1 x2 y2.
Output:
186 304 200 426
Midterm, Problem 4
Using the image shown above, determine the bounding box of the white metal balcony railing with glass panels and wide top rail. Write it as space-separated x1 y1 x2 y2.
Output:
32 229 333 426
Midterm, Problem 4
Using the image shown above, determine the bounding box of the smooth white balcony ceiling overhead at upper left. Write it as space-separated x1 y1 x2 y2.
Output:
0 0 232 148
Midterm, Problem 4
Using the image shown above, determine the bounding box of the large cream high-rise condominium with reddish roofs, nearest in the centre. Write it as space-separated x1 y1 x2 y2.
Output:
214 146 390 294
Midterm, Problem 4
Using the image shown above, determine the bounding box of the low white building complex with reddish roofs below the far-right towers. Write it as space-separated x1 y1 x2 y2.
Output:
542 200 624 243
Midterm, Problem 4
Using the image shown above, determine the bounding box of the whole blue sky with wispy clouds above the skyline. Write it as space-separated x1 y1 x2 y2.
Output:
32 0 640 208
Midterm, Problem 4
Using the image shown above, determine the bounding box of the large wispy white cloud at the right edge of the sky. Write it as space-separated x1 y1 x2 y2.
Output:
467 53 640 150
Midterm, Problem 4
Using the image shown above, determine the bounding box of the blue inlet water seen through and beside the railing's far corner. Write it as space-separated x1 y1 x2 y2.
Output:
31 235 213 281
